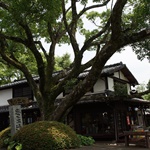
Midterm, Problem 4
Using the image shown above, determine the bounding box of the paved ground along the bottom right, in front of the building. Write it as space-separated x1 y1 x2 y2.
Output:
72 141 150 150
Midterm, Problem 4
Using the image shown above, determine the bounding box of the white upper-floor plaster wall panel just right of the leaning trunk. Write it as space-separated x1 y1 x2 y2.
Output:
93 79 106 93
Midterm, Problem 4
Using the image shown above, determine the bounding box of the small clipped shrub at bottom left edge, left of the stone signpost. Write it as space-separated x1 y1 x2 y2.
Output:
0 127 11 148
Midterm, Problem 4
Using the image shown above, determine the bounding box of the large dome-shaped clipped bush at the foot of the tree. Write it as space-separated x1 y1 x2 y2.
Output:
12 121 81 150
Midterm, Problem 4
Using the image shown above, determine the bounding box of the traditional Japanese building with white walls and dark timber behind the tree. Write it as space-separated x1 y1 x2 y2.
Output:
0 63 150 140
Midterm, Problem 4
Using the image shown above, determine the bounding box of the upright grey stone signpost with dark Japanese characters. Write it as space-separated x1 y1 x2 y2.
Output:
9 105 23 135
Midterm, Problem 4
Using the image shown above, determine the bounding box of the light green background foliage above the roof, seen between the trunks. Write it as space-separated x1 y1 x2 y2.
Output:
0 50 71 85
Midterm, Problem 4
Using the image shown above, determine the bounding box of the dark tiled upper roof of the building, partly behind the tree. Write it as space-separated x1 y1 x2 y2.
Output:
0 62 138 89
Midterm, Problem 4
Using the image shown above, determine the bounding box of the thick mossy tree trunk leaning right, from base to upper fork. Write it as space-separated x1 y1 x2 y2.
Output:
52 42 119 120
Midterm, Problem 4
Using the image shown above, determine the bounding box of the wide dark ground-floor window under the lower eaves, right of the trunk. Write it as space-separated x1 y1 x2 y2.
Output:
82 112 114 134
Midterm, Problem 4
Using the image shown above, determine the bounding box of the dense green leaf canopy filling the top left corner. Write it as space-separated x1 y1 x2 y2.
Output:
0 0 61 39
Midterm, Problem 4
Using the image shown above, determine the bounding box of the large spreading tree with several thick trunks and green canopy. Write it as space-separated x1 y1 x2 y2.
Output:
0 0 150 121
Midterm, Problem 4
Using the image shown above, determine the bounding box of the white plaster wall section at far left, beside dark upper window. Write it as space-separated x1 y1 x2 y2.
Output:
0 89 12 106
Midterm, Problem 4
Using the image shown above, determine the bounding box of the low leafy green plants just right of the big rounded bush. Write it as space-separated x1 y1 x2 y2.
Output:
78 134 95 146
